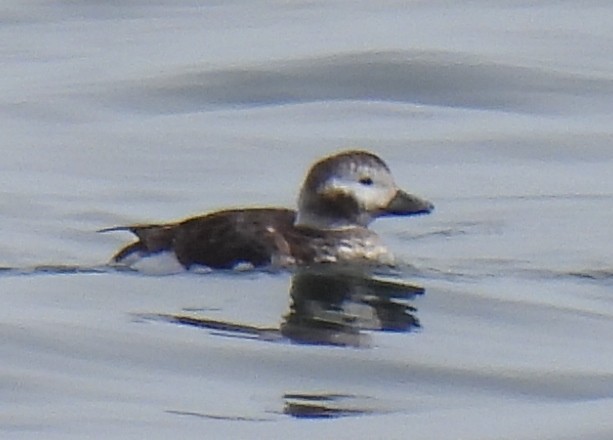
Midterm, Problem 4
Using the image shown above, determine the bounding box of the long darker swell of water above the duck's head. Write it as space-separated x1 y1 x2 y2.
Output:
107 51 613 113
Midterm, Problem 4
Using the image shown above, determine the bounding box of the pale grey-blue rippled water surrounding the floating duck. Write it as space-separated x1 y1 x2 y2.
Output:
0 0 613 439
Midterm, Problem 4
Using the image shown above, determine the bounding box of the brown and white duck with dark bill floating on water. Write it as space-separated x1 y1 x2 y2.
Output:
100 151 434 269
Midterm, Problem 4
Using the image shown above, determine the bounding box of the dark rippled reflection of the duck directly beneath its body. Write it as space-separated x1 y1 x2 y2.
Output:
151 265 424 347
